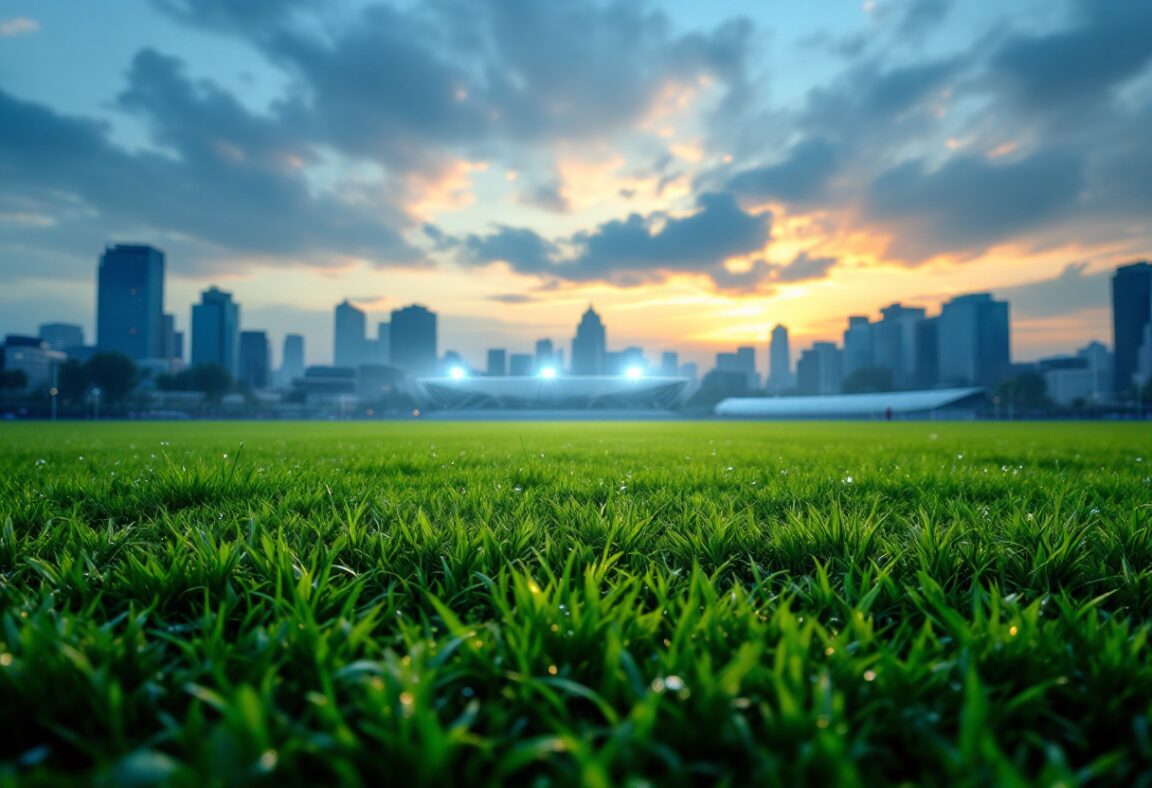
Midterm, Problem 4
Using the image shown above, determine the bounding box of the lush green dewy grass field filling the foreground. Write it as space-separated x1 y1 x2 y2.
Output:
0 423 1152 786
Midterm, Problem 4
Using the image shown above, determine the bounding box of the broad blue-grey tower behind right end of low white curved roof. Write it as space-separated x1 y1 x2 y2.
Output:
937 293 1011 386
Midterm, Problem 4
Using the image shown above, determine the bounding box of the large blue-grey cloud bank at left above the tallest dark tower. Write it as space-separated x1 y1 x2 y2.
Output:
0 51 422 270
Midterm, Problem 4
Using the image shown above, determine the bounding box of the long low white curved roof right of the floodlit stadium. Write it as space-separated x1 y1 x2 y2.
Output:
715 388 984 418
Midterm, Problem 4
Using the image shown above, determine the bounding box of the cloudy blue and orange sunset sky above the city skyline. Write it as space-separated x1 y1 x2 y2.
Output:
0 0 1152 370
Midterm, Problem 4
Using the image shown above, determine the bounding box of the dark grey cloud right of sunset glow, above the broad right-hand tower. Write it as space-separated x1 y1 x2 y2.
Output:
864 151 1083 262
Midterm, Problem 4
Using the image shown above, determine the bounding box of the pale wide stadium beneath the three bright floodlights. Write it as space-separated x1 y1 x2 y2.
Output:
414 376 689 410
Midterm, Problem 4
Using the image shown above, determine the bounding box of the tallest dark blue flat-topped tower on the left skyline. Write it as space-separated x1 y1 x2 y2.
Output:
96 244 165 359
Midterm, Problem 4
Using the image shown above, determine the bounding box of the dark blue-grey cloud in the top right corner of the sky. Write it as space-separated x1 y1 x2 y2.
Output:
988 0 1152 112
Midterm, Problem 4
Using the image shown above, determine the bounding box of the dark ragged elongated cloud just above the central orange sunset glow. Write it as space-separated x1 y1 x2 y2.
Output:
455 194 772 286
